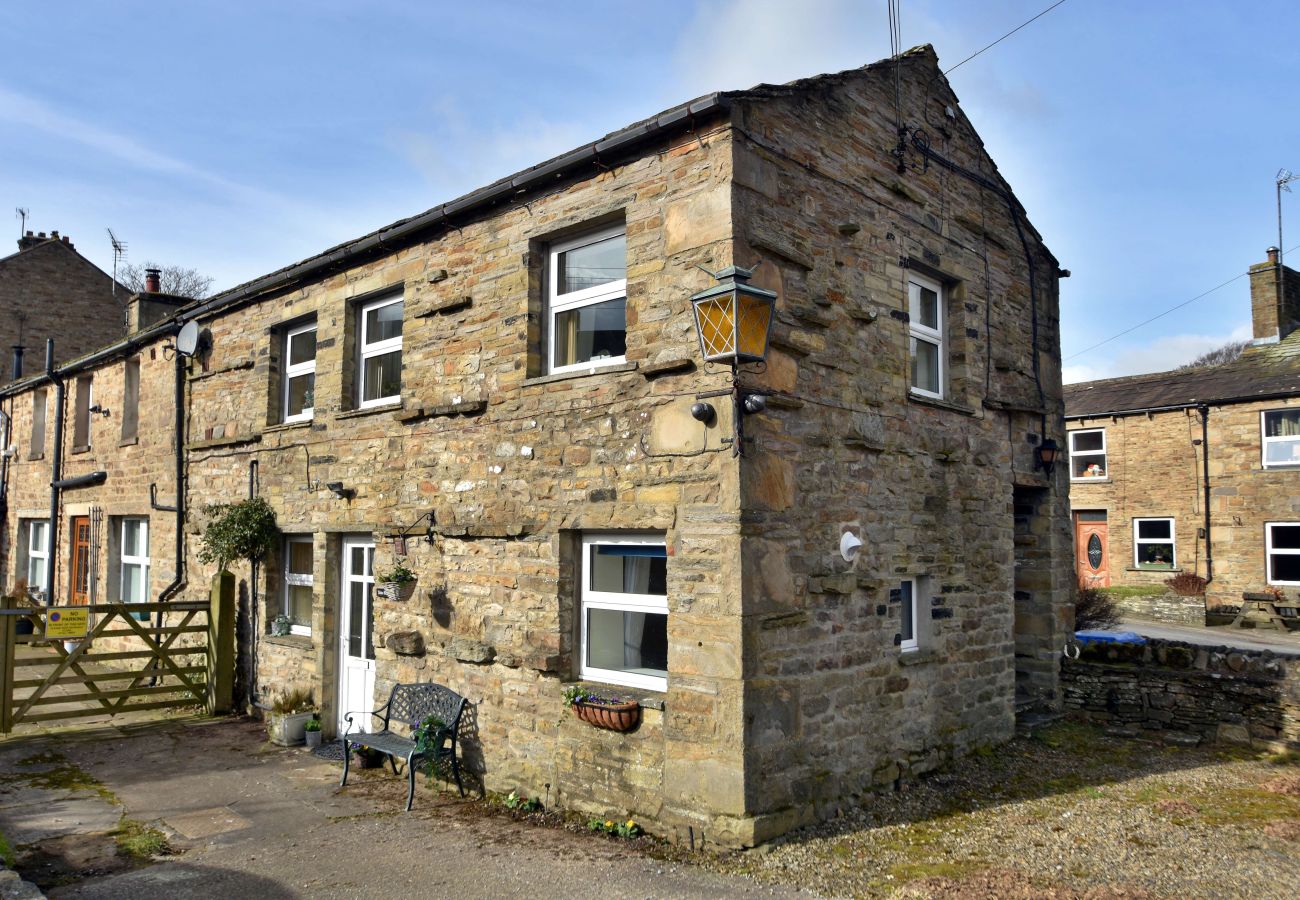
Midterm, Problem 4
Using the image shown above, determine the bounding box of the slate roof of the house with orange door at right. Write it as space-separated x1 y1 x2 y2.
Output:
1065 330 1300 419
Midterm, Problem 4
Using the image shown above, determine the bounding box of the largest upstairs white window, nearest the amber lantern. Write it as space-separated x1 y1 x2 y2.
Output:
546 225 628 373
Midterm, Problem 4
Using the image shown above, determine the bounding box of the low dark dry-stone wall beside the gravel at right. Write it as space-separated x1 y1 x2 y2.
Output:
1061 640 1300 748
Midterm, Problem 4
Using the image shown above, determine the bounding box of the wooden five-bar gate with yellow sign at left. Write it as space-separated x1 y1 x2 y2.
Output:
0 592 224 734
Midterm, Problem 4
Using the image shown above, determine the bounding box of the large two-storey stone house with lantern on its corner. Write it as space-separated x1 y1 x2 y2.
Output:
4 47 1074 845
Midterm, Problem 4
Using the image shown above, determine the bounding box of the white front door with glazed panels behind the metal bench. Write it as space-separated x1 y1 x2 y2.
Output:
338 537 374 735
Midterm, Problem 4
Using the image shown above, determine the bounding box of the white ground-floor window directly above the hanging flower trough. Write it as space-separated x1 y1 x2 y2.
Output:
579 533 668 691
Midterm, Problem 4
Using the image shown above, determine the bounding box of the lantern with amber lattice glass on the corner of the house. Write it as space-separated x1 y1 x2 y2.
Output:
690 265 776 457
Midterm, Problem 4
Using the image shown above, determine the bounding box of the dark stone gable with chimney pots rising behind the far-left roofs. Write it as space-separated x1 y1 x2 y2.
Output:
0 232 130 378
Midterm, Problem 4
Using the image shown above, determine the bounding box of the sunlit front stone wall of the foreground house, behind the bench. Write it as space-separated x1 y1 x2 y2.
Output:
189 122 753 844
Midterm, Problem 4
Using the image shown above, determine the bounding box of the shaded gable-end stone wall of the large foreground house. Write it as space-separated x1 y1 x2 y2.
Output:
736 53 1071 835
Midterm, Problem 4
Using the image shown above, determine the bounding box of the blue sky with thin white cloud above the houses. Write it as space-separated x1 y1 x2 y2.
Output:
0 0 1300 380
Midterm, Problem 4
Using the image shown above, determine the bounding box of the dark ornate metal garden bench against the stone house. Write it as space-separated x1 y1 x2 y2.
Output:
338 683 465 812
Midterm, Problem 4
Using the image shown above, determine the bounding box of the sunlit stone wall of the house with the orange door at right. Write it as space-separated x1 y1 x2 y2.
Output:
1067 399 1300 607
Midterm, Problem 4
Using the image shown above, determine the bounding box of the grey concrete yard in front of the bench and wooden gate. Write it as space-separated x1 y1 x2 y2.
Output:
0 719 809 900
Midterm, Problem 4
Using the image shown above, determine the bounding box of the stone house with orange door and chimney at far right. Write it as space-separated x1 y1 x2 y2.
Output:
1065 248 1300 620
